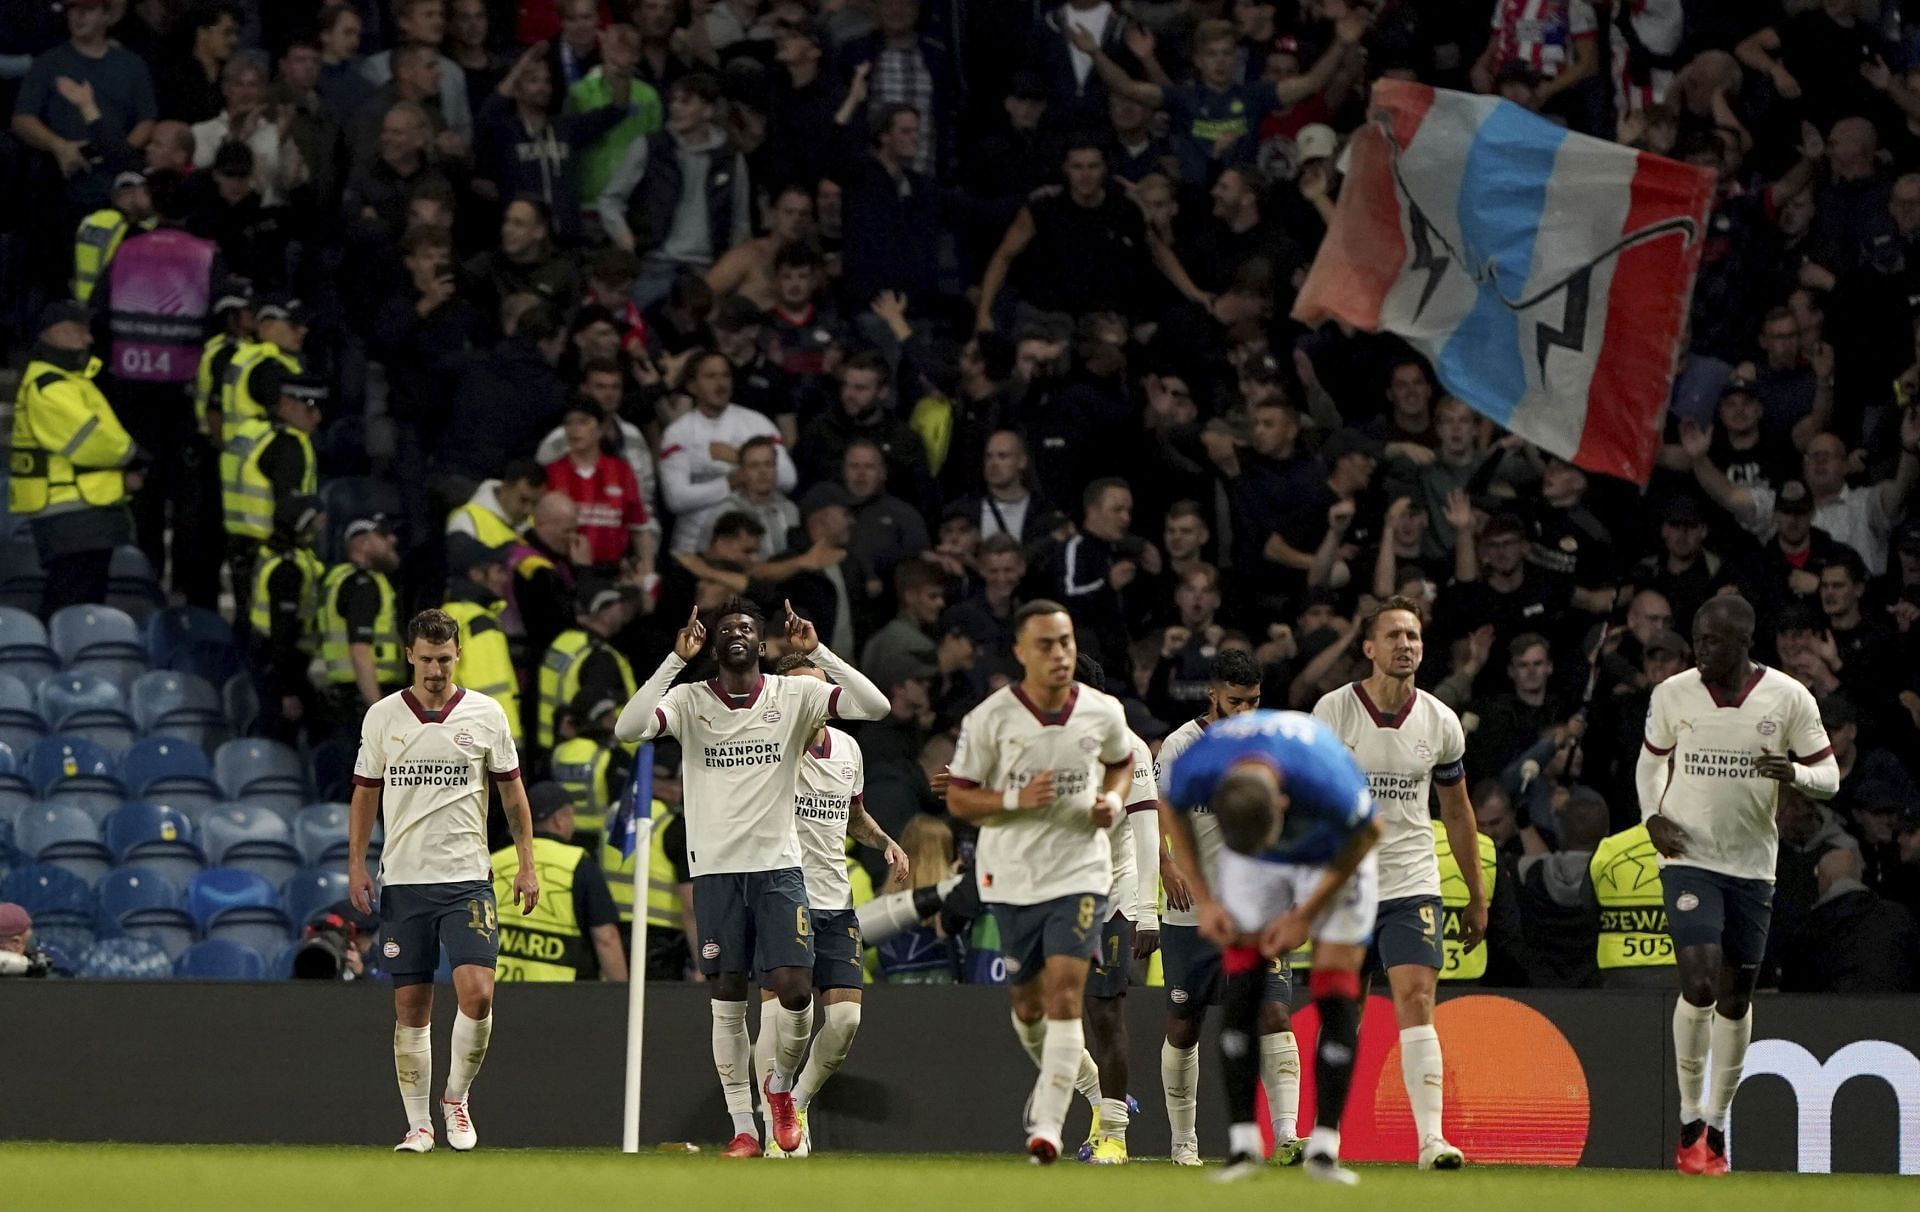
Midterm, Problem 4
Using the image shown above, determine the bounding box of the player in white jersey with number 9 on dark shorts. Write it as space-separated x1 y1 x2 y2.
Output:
1313 597 1486 1170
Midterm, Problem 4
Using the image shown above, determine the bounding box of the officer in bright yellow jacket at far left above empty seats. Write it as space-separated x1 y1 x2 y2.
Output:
8 302 138 618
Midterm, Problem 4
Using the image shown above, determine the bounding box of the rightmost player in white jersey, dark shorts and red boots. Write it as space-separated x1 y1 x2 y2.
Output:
1634 595 1839 1174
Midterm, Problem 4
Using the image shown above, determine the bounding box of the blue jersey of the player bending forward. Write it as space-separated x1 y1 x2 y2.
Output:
1165 711 1374 866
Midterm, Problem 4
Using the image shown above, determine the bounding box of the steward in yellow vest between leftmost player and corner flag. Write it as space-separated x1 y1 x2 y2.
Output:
493 782 626 982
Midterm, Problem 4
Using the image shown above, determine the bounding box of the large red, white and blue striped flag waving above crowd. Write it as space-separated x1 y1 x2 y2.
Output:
1294 81 1713 482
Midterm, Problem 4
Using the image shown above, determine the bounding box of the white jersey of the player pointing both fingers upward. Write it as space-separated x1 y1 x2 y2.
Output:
655 674 841 876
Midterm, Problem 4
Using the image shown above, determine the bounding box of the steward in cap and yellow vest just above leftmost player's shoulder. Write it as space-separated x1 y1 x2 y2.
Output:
321 515 407 736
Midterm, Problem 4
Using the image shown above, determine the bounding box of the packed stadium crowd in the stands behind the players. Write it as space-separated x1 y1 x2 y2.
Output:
0 0 1920 991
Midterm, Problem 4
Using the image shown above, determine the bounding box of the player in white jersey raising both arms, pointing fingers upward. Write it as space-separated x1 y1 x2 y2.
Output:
614 599 889 1156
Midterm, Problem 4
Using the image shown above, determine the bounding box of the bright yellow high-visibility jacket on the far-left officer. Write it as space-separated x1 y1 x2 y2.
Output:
8 359 132 515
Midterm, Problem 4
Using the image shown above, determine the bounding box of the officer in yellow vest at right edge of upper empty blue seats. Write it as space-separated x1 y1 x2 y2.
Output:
248 494 326 743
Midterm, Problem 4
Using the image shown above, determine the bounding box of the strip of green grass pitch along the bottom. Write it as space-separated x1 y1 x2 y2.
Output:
0 1143 1914 1212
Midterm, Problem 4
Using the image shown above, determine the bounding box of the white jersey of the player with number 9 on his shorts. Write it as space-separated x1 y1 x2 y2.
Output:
1313 682 1467 901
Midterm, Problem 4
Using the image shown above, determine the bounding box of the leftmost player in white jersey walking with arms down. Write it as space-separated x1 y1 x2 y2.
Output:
348 611 540 1152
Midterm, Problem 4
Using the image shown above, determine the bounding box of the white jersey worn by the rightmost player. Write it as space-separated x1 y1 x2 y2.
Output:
1640 665 1834 882
